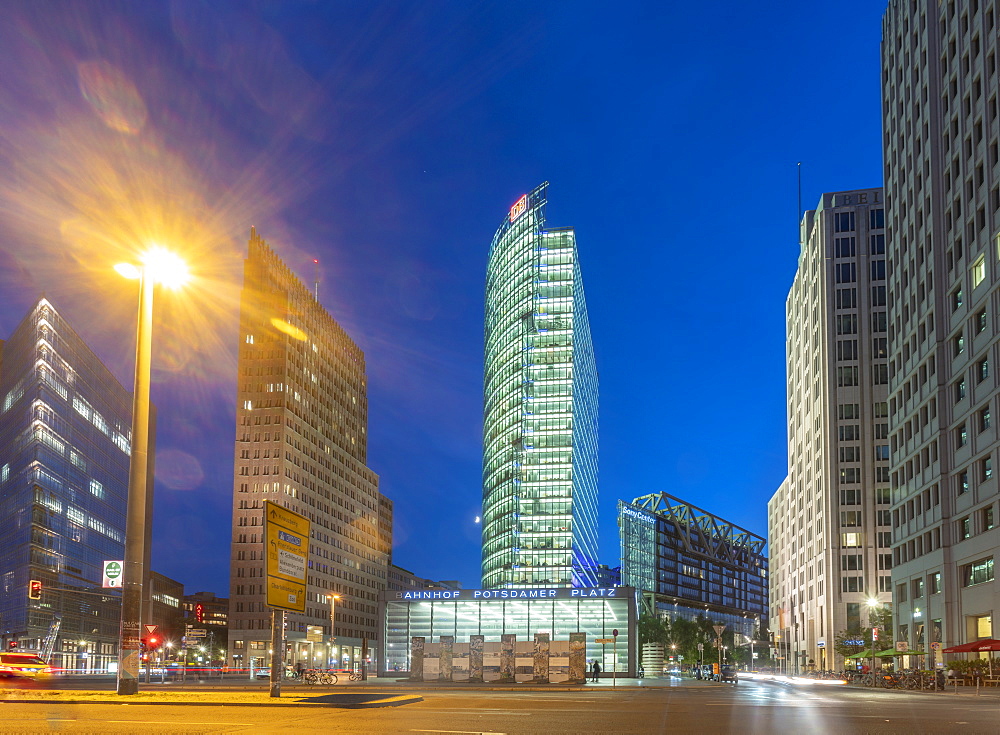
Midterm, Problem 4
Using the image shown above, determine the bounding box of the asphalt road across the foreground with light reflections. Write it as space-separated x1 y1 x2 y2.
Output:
0 681 1000 735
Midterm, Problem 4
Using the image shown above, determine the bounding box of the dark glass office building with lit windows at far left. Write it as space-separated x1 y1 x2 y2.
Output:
0 299 132 671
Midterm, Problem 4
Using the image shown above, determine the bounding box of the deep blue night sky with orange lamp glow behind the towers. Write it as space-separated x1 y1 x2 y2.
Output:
0 0 884 594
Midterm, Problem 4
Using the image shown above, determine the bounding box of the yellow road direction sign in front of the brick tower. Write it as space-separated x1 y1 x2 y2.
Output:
264 500 309 612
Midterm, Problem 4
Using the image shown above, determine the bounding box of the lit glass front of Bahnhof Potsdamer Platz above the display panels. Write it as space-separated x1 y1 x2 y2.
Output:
382 587 637 671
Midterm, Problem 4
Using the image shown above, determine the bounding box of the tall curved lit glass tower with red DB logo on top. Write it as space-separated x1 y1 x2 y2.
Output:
482 183 597 588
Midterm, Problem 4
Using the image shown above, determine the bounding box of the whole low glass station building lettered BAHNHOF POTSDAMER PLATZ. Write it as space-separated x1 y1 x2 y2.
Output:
379 587 638 681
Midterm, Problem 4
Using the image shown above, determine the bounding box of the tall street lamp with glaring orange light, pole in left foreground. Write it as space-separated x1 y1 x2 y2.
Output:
115 247 187 694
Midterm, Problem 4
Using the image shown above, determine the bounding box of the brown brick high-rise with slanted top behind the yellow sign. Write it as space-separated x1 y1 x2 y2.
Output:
228 230 392 667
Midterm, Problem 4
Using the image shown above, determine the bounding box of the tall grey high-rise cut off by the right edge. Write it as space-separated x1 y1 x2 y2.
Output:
882 0 1000 650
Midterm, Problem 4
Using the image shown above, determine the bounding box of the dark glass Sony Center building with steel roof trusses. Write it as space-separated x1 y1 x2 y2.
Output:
618 493 768 633
